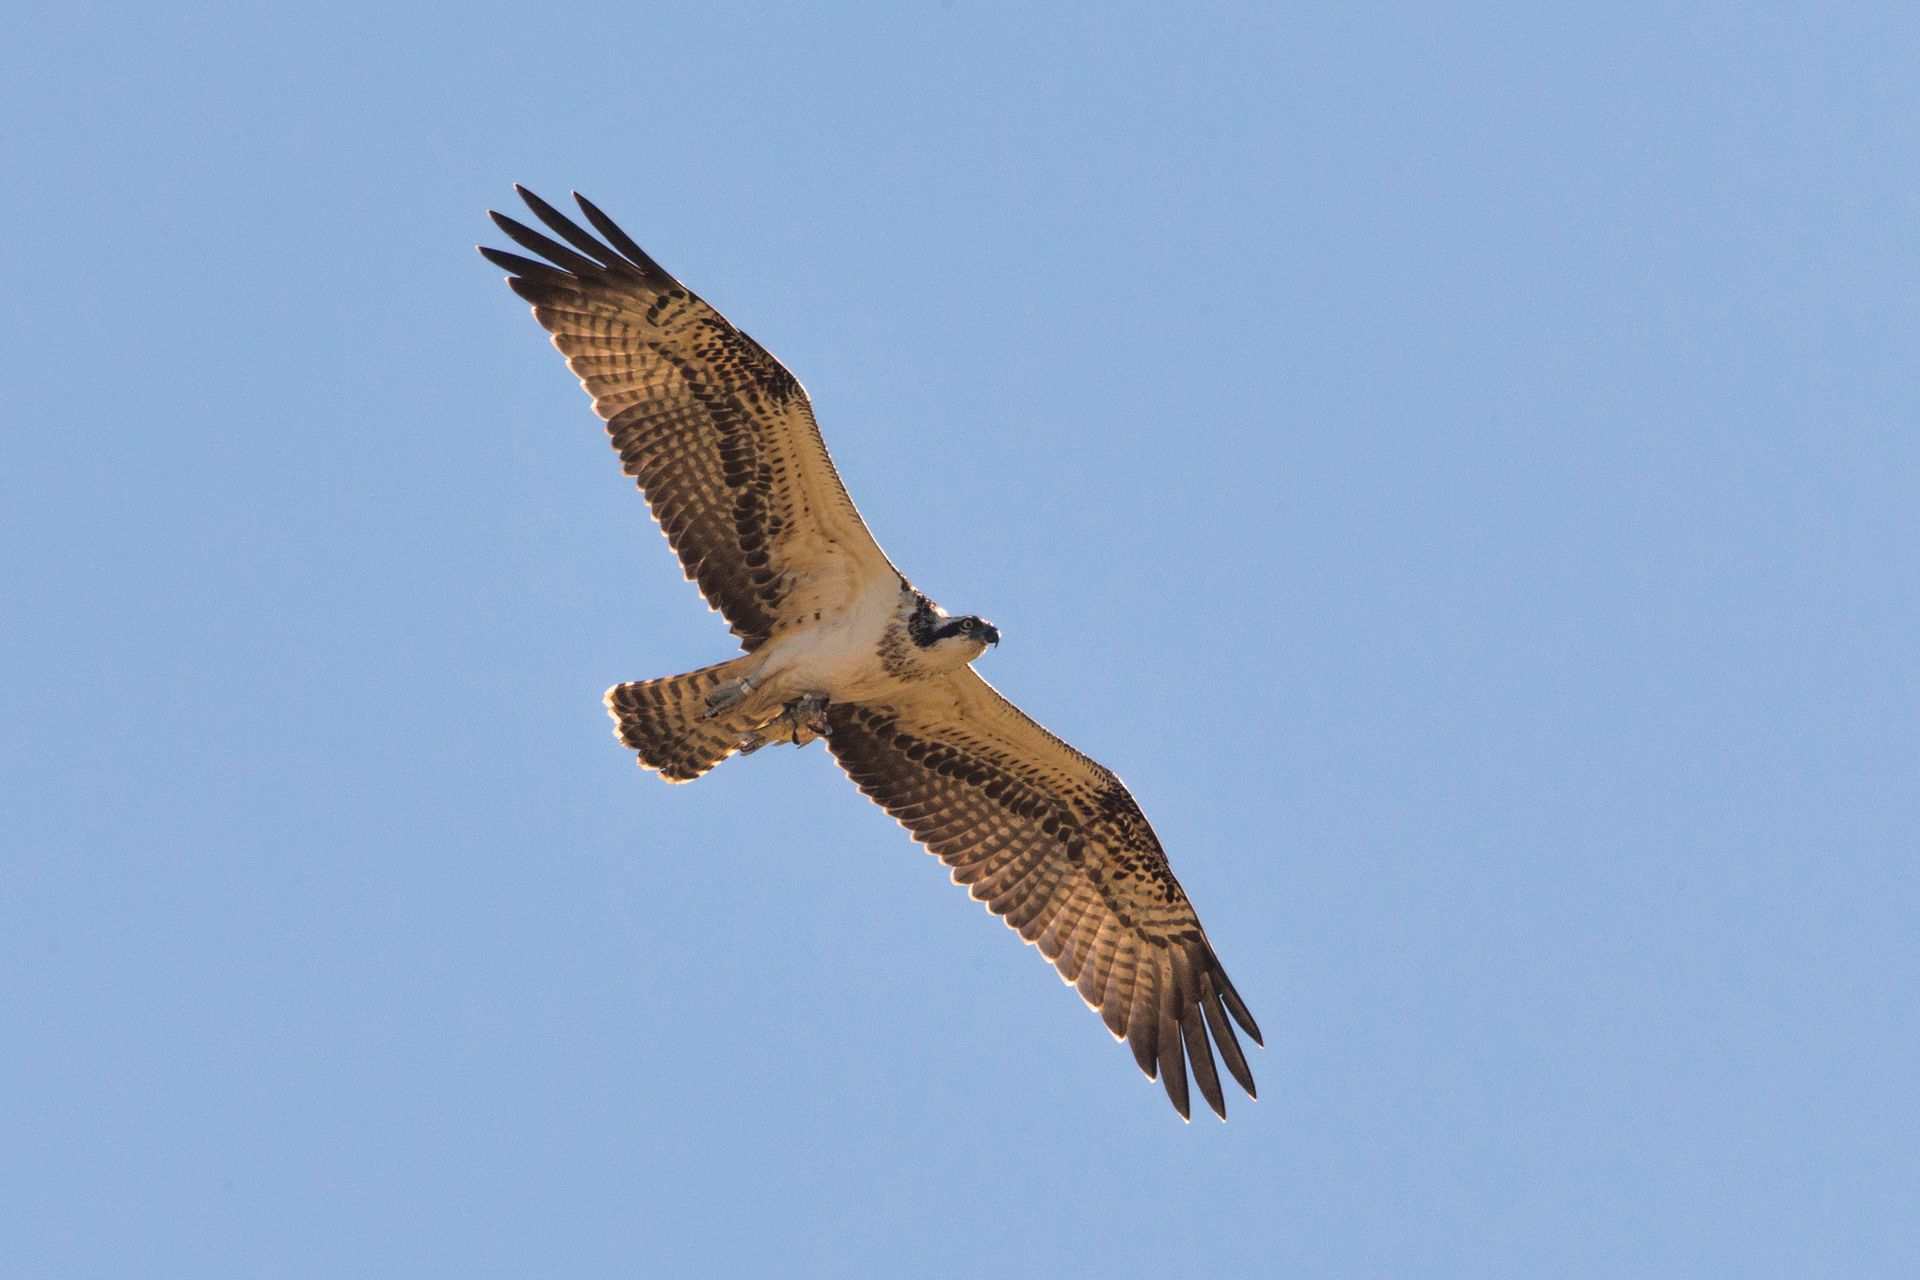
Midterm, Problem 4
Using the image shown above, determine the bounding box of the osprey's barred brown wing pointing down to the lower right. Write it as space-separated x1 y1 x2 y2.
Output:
828 668 1260 1119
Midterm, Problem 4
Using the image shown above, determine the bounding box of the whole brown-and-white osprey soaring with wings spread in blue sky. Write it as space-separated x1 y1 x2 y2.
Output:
480 186 1260 1119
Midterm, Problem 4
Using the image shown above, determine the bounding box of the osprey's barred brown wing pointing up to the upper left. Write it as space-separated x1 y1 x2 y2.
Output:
480 188 899 651
